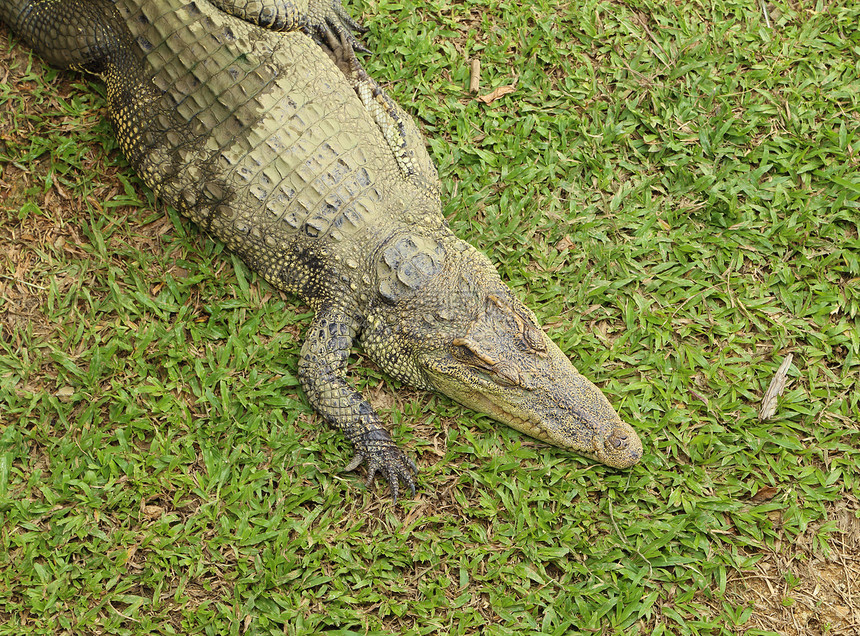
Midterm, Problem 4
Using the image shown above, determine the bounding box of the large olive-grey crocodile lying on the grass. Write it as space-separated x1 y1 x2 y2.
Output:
0 0 642 501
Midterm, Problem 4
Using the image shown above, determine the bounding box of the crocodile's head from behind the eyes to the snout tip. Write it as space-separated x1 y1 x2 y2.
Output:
419 286 642 468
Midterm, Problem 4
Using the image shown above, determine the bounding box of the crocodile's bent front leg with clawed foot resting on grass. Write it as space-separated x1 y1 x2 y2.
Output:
299 308 418 502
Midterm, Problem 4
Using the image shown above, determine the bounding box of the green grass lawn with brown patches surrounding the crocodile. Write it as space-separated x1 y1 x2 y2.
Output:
0 0 860 636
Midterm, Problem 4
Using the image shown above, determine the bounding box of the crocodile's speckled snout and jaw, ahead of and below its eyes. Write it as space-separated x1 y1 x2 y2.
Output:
422 336 642 468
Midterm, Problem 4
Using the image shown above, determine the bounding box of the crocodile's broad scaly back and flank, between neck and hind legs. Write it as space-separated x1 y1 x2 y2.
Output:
106 0 443 300
